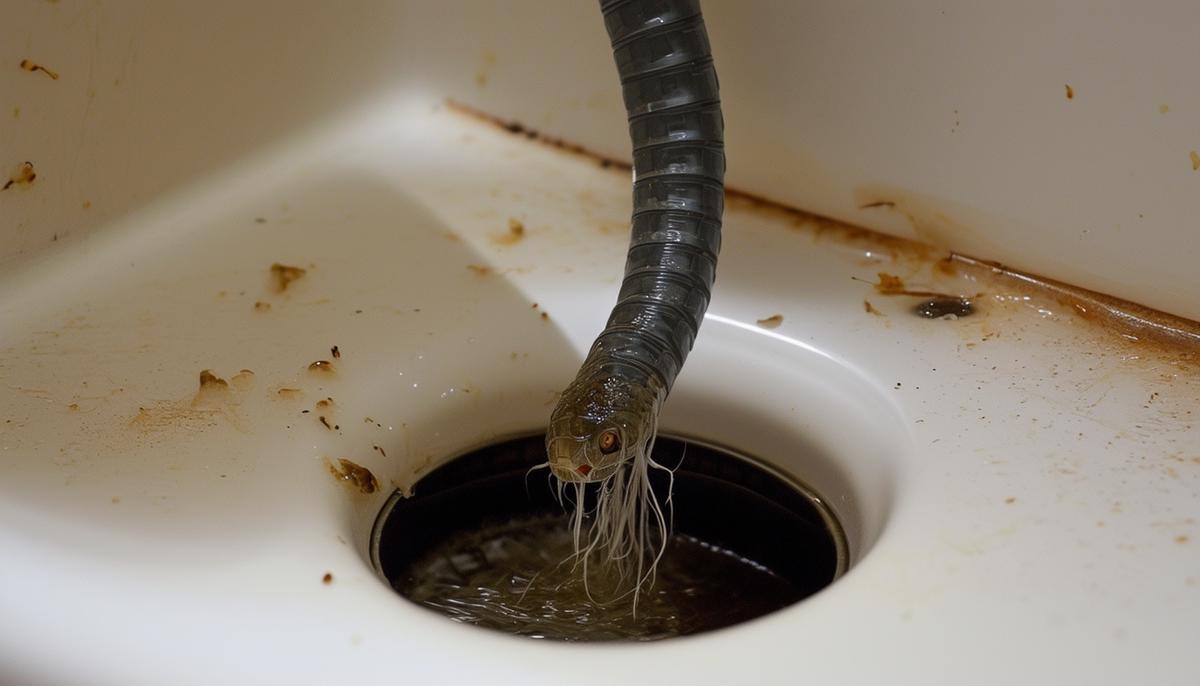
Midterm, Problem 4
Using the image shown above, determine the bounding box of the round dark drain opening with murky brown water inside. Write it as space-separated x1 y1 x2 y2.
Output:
371 435 847 642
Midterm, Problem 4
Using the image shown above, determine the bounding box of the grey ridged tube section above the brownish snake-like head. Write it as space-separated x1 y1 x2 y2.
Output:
588 0 725 391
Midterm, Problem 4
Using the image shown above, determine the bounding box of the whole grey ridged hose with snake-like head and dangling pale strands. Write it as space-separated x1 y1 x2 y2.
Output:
546 0 725 599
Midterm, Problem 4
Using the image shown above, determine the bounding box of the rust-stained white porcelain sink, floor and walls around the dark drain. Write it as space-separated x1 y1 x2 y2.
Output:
0 0 1200 685
